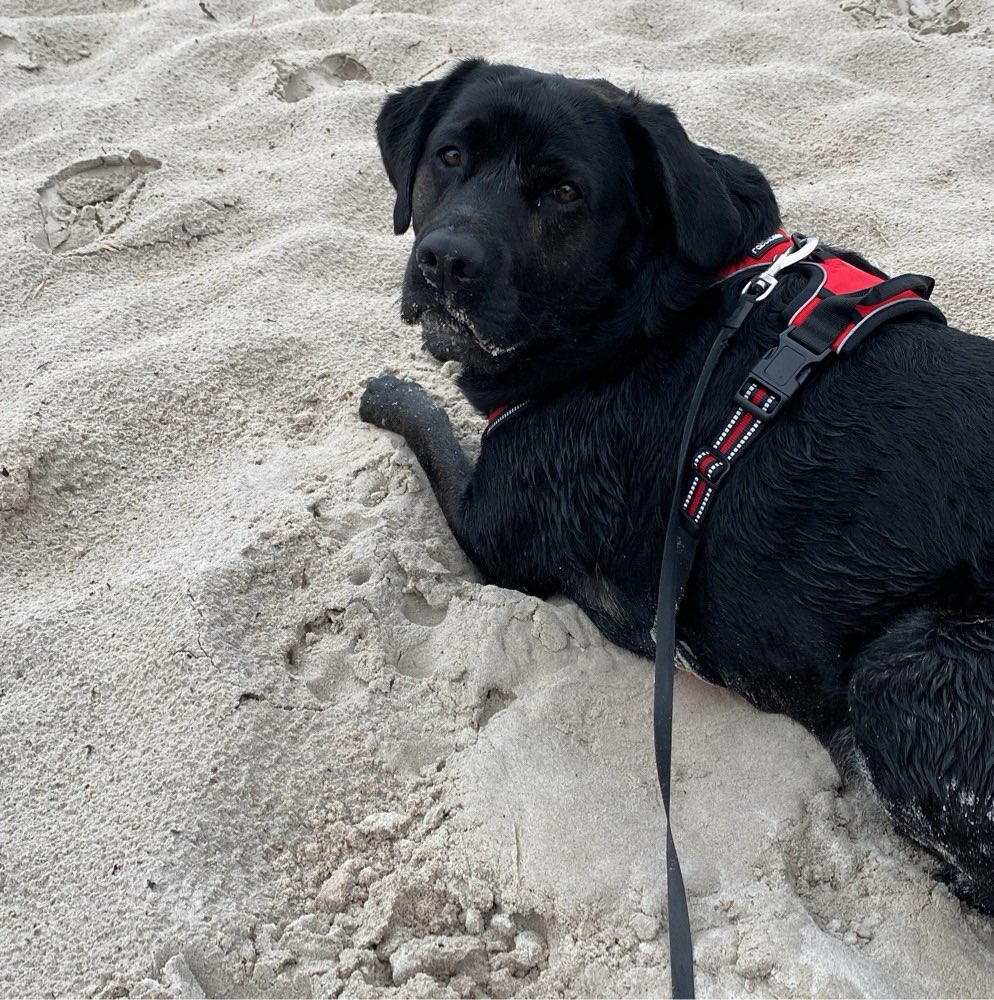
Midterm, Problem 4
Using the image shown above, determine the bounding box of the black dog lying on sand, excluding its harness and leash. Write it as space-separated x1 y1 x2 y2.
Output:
360 61 994 912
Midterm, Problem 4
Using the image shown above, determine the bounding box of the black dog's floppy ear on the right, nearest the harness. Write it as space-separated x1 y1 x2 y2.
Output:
619 95 743 273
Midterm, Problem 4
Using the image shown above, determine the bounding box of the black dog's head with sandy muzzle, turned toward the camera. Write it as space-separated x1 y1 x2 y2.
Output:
377 60 776 386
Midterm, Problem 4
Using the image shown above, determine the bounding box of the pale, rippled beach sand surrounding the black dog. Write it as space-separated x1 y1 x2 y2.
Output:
0 0 994 997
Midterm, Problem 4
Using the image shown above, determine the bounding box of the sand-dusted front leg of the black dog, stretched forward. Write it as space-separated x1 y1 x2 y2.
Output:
359 375 473 556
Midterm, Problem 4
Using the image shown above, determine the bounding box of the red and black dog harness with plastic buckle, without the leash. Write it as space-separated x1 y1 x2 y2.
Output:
683 229 946 530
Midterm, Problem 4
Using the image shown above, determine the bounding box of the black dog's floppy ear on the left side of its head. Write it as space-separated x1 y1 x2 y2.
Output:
376 59 486 235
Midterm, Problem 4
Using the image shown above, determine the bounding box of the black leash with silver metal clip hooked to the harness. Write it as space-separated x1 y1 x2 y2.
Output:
652 240 818 1000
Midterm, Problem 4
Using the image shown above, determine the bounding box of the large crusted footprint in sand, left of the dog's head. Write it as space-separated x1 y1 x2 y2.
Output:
35 151 162 253
